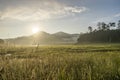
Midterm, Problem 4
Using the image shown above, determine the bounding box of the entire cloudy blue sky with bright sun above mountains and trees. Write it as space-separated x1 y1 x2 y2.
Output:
0 0 120 38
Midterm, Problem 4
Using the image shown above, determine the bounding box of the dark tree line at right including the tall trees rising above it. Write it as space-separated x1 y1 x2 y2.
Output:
78 20 120 43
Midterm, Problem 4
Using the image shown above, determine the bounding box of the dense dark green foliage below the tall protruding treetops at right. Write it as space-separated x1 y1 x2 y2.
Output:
78 30 120 43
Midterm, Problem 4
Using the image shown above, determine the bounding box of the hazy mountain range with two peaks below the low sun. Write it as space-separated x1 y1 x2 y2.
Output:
5 31 79 45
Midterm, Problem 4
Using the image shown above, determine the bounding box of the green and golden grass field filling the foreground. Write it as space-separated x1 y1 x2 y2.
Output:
0 44 120 80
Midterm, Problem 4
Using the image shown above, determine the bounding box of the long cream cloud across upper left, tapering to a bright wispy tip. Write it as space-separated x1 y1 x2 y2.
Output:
0 0 88 21
